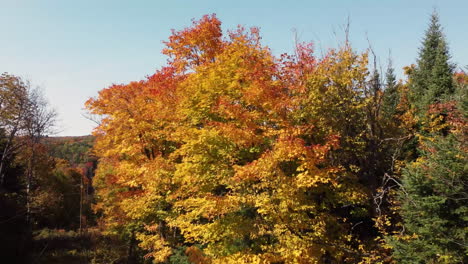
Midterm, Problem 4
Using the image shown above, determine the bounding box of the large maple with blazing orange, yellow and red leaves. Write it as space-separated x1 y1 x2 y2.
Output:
83 15 398 263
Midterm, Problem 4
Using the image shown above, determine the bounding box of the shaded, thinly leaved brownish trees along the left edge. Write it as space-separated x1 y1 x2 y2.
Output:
0 73 95 263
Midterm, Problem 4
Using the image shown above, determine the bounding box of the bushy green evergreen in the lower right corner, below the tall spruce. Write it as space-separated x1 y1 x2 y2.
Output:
391 135 468 263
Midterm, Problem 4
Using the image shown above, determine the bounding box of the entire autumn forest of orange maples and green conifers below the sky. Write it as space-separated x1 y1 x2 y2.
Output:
0 11 468 264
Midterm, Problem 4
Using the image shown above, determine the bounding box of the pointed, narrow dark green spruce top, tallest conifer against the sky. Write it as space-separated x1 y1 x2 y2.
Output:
411 11 454 111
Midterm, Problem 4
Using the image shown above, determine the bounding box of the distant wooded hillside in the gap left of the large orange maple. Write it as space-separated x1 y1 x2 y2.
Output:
44 135 94 166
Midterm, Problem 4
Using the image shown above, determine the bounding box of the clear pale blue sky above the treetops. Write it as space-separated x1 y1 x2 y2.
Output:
0 0 468 136
